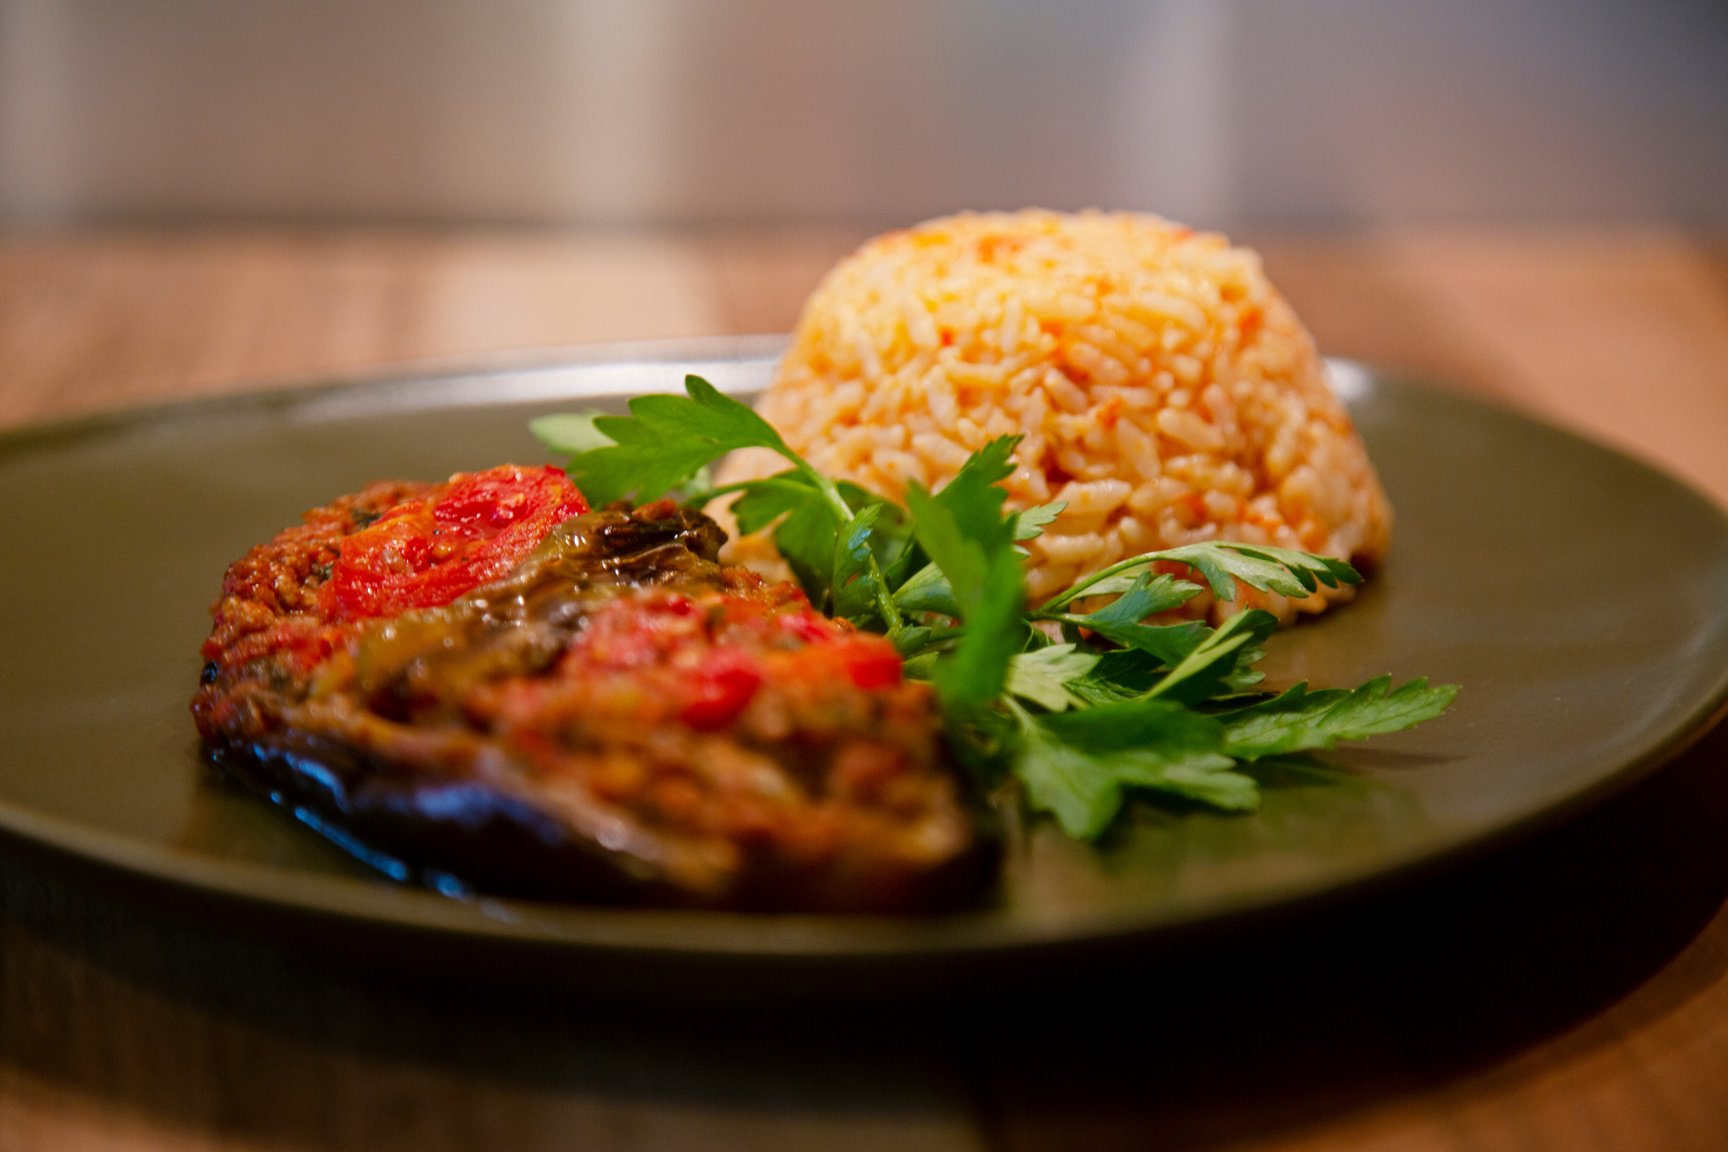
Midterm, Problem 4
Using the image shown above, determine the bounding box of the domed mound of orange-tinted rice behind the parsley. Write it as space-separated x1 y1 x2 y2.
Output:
727 211 1391 618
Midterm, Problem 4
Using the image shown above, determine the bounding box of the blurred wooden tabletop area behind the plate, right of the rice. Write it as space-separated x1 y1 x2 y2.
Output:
1260 230 1728 503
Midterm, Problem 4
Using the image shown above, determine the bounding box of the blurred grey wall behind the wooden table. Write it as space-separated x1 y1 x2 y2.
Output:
0 0 1728 228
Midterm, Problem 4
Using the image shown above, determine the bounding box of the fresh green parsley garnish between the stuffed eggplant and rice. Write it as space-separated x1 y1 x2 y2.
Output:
532 377 1458 839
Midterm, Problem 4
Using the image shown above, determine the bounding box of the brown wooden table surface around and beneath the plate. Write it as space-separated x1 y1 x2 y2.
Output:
0 228 1728 1152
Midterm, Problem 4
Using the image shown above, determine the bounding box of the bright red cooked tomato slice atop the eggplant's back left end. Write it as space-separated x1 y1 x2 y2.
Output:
320 465 588 620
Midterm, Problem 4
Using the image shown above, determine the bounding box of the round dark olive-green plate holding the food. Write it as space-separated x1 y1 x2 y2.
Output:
0 340 1728 995
